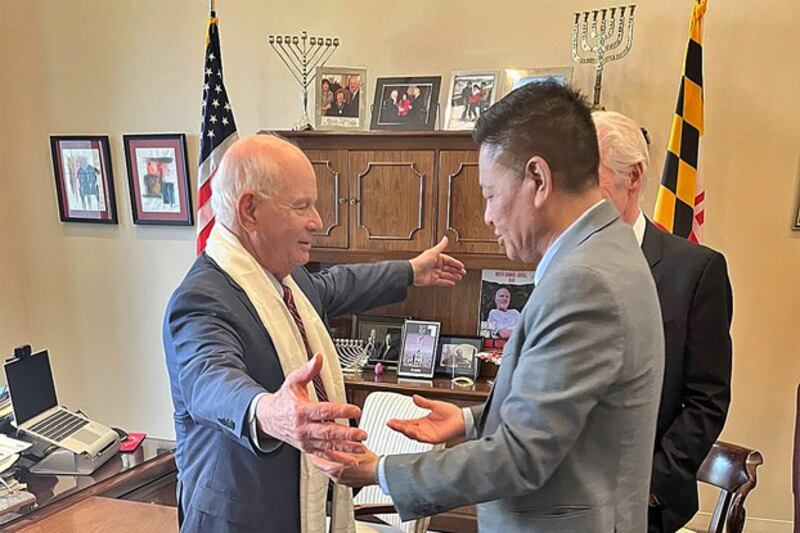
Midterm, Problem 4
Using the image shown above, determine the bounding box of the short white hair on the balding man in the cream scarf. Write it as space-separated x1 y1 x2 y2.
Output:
211 135 280 229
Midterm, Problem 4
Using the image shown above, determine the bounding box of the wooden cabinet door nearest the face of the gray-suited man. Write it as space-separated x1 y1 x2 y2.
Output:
436 150 505 255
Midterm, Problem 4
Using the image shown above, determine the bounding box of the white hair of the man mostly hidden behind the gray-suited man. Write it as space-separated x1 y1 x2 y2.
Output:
592 111 650 194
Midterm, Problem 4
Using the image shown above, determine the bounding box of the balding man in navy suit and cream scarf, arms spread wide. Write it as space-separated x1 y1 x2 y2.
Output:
164 136 465 533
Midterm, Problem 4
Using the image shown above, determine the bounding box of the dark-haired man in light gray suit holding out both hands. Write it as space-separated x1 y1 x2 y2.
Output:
318 83 664 533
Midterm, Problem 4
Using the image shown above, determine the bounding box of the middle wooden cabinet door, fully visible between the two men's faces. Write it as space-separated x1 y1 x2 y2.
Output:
349 150 435 252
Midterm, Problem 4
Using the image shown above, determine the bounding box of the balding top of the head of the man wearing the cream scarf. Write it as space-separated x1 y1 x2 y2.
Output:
211 135 313 230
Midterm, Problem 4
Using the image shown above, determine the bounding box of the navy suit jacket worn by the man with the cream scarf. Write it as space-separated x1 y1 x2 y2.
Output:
164 254 413 533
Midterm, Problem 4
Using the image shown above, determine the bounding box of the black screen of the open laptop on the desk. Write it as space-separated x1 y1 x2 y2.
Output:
5 350 58 426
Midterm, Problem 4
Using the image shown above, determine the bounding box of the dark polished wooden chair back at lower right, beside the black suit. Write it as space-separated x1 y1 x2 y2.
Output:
697 441 764 533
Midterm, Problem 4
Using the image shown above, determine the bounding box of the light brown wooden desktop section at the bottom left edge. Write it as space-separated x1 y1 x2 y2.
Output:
20 496 178 533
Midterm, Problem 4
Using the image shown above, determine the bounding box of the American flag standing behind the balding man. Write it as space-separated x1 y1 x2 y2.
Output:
197 10 239 255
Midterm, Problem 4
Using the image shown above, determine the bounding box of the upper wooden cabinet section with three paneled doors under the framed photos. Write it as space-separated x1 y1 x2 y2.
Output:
284 132 511 268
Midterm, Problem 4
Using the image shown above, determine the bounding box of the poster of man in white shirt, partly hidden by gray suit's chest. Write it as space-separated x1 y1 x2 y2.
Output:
478 270 534 339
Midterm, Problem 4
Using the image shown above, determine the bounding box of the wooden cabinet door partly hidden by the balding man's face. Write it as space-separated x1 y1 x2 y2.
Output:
305 150 349 248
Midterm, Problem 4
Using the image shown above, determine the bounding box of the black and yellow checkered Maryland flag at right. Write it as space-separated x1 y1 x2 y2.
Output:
653 0 707 242
